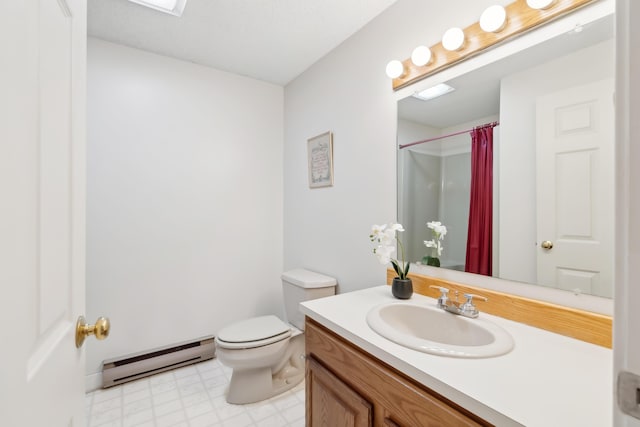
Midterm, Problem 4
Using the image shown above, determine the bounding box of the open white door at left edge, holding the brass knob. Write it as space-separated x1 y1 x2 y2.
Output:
0 0 91 427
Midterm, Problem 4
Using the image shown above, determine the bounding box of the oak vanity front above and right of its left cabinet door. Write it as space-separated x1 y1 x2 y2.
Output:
305 318 492 427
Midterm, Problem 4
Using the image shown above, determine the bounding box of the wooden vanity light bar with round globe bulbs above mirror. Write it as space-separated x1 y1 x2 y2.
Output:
387 0 597 90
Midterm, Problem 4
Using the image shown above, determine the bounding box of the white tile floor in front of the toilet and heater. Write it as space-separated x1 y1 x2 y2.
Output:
86 359 305 427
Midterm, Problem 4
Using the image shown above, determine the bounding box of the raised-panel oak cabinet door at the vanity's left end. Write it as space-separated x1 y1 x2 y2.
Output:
306 357 373 427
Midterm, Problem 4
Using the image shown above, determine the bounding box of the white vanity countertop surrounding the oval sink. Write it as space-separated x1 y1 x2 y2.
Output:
300 286 613 427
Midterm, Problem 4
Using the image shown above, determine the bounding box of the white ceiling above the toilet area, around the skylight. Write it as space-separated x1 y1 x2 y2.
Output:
88 0 397 85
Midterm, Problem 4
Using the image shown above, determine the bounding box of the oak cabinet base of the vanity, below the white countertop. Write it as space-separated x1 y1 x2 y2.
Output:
306 319 492 427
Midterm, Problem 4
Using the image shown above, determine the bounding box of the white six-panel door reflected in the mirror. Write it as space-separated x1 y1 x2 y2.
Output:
536 79 615 297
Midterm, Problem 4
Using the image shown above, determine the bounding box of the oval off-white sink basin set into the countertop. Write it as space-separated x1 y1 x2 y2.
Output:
367 302 513 358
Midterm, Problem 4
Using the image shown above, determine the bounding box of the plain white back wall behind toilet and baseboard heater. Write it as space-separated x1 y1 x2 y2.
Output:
87 39 283 382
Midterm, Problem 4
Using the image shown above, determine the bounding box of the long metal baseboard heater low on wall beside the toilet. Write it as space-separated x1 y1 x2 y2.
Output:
102 337 215 388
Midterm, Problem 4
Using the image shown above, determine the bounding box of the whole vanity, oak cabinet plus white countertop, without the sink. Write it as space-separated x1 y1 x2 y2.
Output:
300 286 613 427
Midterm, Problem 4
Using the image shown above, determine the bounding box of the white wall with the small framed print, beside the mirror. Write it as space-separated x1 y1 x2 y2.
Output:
284 0 510 292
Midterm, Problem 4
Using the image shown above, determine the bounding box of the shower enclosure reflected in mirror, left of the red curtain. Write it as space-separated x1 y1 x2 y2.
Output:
398 114 499 271
